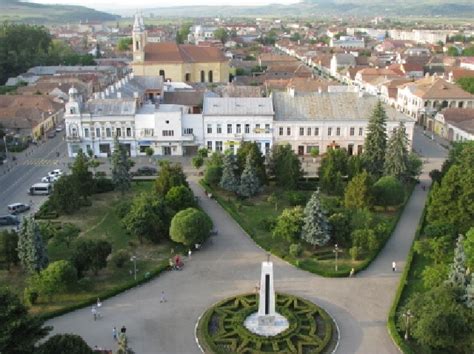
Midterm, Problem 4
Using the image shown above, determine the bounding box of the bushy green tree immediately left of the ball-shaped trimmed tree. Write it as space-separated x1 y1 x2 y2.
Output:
122 193 169 243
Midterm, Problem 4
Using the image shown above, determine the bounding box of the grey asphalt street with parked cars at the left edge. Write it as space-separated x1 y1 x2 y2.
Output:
0 132 68 224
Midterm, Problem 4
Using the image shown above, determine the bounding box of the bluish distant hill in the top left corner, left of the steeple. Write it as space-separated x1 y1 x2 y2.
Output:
0 0 118 24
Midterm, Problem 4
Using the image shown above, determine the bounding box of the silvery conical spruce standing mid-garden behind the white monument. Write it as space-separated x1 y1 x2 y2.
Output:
301 191 331 246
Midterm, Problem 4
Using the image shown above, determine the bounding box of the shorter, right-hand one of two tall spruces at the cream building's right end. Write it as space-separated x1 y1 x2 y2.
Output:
384 122 409 180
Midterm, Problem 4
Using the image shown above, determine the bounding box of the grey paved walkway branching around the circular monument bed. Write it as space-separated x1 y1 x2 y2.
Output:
48 128 445 354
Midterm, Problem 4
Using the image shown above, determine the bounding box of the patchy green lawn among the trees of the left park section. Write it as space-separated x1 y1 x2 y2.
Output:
0 182 174 315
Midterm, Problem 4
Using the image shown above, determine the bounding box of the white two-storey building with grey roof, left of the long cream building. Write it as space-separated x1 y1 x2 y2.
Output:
203 97 274 154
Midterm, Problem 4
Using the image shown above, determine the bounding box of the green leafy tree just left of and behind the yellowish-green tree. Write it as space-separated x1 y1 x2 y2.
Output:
318 149 348 195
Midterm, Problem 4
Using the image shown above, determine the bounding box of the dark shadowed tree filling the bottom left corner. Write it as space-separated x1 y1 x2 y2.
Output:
0 287 53 354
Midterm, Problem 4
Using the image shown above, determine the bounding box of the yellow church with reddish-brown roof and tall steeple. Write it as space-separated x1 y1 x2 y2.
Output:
132 15 229 83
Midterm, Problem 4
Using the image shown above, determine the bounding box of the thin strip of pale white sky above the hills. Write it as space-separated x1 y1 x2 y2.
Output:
33 0 299 10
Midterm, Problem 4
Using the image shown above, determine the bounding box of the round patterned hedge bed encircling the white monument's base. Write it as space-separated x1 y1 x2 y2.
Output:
196 293 337 354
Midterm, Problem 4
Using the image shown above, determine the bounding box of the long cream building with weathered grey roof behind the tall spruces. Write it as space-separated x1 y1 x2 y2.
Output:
273 92 415 155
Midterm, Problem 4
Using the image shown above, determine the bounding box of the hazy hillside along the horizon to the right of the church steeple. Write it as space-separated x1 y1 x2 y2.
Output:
135 0 474 18
